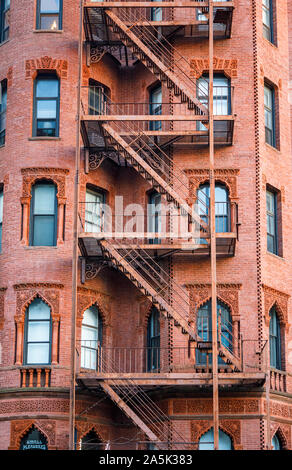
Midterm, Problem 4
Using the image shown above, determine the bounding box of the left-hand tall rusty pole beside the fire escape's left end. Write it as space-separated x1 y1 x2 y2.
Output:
69 0 83 450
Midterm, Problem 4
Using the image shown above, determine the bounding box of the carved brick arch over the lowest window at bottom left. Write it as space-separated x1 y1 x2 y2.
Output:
8 420 56 450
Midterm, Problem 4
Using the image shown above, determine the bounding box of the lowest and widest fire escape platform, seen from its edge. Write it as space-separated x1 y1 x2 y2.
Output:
77 371 266 390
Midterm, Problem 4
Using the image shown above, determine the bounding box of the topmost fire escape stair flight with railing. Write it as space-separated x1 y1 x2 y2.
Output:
106 9 208 116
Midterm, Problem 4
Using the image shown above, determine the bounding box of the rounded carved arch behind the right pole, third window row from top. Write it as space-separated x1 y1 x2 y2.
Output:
185 168 239 201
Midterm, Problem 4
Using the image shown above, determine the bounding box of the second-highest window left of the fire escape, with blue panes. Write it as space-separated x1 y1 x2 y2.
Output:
33 74 60 137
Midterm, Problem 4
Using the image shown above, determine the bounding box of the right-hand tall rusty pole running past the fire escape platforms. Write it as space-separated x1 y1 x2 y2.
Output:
209 0 219 450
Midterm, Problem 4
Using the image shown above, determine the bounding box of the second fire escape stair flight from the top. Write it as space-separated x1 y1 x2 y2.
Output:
102 123 209 231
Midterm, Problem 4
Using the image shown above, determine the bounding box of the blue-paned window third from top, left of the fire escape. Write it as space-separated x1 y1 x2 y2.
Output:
30 181 57 246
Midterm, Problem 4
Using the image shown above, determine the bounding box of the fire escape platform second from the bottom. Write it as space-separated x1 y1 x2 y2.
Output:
78 232 237 258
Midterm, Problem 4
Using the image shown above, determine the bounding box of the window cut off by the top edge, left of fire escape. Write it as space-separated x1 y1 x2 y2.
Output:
36 0 62 30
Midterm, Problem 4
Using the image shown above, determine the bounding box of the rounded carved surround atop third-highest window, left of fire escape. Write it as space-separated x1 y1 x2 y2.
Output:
21 168 69 203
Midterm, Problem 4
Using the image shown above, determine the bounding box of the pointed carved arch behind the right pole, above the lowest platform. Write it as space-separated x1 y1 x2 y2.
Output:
185 284 241 321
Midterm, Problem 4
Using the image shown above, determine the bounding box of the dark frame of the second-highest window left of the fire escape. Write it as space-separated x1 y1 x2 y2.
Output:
32 72 61 139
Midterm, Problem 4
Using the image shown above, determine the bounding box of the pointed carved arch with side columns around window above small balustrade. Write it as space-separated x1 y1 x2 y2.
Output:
13 283 64 365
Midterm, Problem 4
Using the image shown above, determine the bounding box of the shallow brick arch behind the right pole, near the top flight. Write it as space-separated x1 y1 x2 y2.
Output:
190 57 238 79
